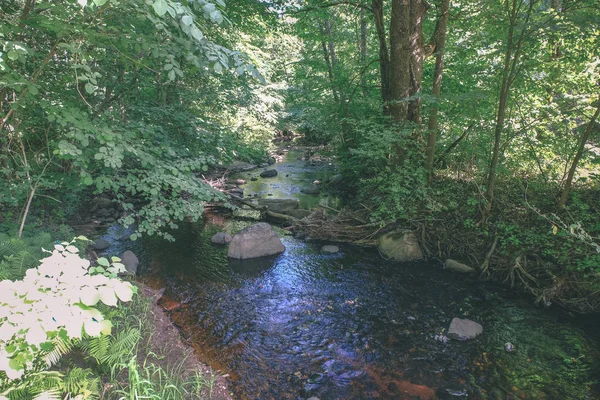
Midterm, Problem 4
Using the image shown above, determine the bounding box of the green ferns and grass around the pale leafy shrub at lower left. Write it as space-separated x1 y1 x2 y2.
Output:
0 233 216 400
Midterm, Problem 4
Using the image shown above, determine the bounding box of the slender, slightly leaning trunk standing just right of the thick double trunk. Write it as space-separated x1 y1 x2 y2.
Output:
425 0 450 176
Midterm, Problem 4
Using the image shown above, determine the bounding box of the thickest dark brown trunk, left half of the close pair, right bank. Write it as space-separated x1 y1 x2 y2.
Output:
390 0 411 123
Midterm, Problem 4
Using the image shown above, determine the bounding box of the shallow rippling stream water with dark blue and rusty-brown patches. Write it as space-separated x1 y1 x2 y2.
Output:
107 150 600 400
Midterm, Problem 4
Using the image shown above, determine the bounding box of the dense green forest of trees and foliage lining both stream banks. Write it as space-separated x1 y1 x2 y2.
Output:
0 0 600 312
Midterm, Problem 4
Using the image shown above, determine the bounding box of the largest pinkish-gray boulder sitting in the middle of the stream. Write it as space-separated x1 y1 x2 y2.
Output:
227 222 285 260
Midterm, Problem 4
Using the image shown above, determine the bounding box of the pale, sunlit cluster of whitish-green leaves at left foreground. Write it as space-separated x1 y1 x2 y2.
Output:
0 241 136 381
